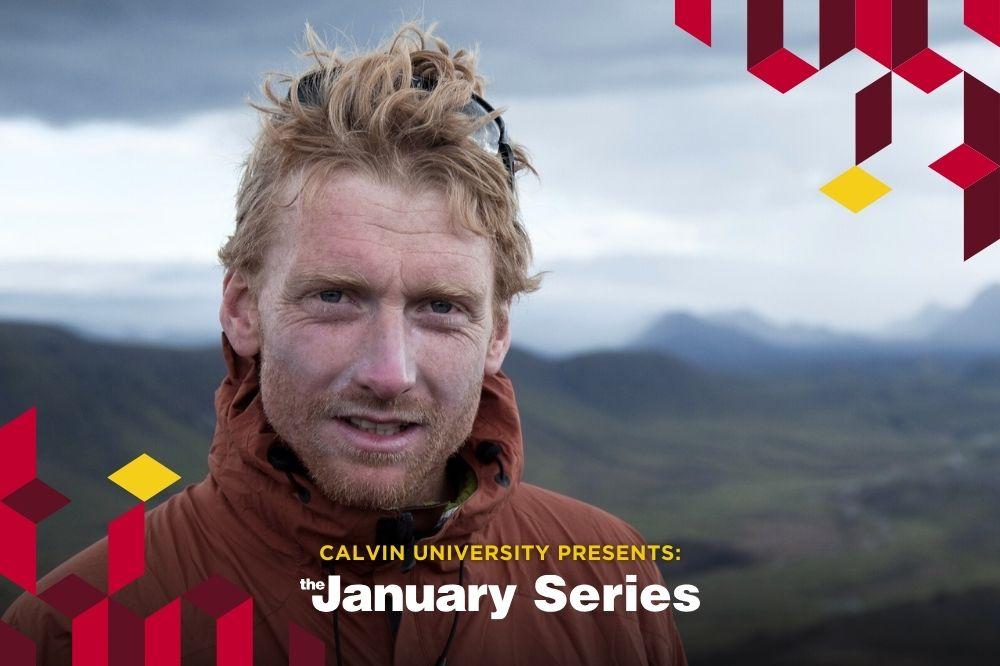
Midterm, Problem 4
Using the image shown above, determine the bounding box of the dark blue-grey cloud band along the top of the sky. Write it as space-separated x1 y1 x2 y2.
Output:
0 0 967 123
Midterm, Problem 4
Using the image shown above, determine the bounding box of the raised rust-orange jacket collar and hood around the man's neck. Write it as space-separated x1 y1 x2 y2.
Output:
209 333 524 565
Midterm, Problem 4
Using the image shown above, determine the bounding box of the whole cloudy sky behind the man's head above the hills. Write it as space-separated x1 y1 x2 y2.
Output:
0 0 1000 351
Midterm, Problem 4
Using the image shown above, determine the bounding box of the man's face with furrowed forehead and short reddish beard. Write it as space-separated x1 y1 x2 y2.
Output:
237 174 509 508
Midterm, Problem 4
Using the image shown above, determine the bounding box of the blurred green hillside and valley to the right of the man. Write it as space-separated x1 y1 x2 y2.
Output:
508 354 1000 664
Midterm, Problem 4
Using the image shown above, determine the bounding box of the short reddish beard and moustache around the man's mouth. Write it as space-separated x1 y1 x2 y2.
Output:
260 345 483 509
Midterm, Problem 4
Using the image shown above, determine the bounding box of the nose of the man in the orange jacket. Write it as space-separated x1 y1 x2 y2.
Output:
355 308 417 400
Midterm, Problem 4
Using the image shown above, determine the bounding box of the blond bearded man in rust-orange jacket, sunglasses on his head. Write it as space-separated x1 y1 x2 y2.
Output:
4 26 685 665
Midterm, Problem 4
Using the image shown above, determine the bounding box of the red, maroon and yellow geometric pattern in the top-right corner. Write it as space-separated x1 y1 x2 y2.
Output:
674 0 1000 260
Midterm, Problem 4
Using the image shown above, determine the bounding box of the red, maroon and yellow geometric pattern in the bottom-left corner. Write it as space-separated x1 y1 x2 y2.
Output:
0 409 278 666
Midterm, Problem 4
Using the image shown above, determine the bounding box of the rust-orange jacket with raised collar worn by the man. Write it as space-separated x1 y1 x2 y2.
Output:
3 335 686 666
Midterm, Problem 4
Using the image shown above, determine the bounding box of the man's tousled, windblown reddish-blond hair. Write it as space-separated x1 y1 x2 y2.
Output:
219 23 541 310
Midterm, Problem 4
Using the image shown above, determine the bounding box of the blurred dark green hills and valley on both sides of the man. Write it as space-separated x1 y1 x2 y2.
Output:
0 324 1000 664
